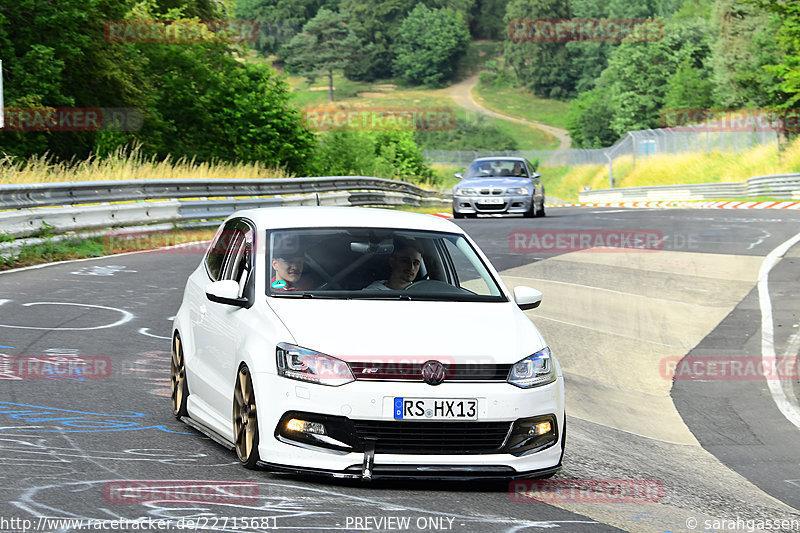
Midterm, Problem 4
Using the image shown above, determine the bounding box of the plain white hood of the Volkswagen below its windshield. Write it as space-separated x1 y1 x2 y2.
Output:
269 298 545 364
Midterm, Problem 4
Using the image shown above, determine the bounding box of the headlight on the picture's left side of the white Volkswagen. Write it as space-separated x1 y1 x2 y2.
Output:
275 342 355 387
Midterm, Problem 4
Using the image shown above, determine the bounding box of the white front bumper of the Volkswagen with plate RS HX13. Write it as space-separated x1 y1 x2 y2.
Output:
256 374 564 480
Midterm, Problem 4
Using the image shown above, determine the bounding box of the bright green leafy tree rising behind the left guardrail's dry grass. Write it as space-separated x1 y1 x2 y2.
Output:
139 44 315 172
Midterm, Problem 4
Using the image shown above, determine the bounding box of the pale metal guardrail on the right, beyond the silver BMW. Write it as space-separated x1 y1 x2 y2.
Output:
578 174 800 202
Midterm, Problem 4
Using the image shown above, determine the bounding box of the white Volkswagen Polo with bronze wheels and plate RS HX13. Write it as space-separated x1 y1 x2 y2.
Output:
171 207 566 479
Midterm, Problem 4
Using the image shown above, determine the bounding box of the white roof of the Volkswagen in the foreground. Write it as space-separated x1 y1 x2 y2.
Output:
228 206 464 234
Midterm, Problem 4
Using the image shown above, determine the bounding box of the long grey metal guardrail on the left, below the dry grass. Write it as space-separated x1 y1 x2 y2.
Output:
0 176 451 238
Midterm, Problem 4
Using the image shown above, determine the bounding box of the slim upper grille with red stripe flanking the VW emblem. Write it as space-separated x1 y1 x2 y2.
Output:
350 362 511 382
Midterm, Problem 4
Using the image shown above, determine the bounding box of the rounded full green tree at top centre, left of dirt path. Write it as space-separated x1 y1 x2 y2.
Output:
393 4 469 84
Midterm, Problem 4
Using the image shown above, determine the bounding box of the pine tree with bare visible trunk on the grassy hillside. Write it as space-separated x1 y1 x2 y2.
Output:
286 8 358 102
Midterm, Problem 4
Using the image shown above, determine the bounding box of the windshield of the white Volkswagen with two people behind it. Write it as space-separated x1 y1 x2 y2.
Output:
267 228 507 302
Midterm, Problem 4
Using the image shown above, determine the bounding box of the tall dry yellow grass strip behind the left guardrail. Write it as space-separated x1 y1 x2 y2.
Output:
0 143 290 184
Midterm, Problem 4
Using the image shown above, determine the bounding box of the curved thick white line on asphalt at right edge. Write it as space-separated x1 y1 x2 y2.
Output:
758 233 800 429
